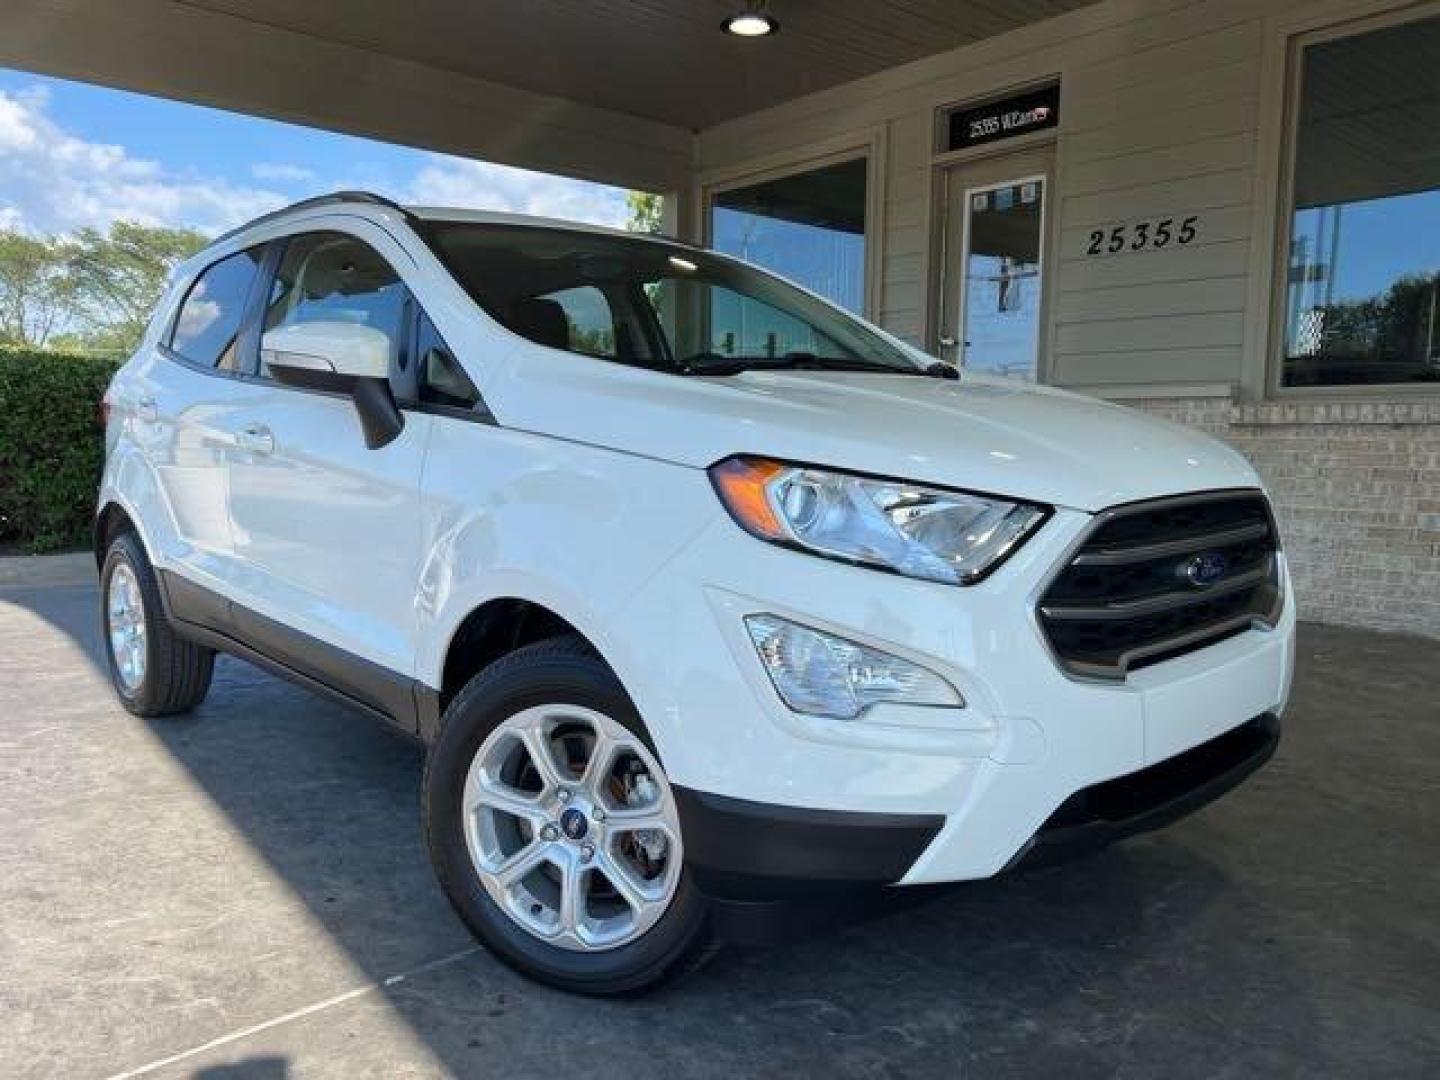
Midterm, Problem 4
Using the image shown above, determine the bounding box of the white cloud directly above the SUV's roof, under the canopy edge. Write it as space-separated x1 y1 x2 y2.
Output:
403 154 629 228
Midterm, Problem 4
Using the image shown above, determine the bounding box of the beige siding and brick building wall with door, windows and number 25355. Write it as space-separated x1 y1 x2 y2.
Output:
685 0 1440 636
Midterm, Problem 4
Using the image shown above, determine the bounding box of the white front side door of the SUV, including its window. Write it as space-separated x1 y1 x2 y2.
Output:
229 222 431 688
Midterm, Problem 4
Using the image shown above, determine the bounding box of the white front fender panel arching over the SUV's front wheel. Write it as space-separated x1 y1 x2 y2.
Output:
416 419 724 753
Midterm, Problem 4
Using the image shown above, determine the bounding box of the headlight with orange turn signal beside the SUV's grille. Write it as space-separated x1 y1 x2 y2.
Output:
710 458 1047 585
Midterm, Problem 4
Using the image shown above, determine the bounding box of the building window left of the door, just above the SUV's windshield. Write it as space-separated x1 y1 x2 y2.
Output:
710 157 865 314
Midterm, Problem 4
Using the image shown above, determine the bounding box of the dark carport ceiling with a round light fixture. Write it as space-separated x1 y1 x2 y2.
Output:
174 0 1086 131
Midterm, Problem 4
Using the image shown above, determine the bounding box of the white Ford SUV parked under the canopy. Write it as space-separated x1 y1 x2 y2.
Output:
95 194 1295 994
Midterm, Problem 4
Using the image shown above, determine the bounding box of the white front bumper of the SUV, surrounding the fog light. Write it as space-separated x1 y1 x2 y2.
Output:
608 510 1295 894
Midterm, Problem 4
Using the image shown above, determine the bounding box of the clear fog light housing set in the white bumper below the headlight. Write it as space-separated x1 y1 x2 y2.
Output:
744 615 965 720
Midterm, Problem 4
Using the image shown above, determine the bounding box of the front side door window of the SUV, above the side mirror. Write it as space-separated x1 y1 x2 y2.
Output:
262 232 409 374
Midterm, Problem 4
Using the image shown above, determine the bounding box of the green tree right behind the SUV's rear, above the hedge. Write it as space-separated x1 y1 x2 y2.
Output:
60 222 206 351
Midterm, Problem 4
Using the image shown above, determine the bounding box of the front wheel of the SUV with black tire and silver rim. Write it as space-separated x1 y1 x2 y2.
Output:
425 636 711 995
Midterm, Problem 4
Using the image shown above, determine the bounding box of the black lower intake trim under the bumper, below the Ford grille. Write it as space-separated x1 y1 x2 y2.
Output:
1007 713 1280 870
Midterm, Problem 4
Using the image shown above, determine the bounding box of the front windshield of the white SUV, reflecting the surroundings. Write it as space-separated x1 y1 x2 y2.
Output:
426 222 933 374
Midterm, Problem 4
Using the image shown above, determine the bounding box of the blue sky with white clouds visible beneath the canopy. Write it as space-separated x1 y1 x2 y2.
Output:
0 69 626 233
